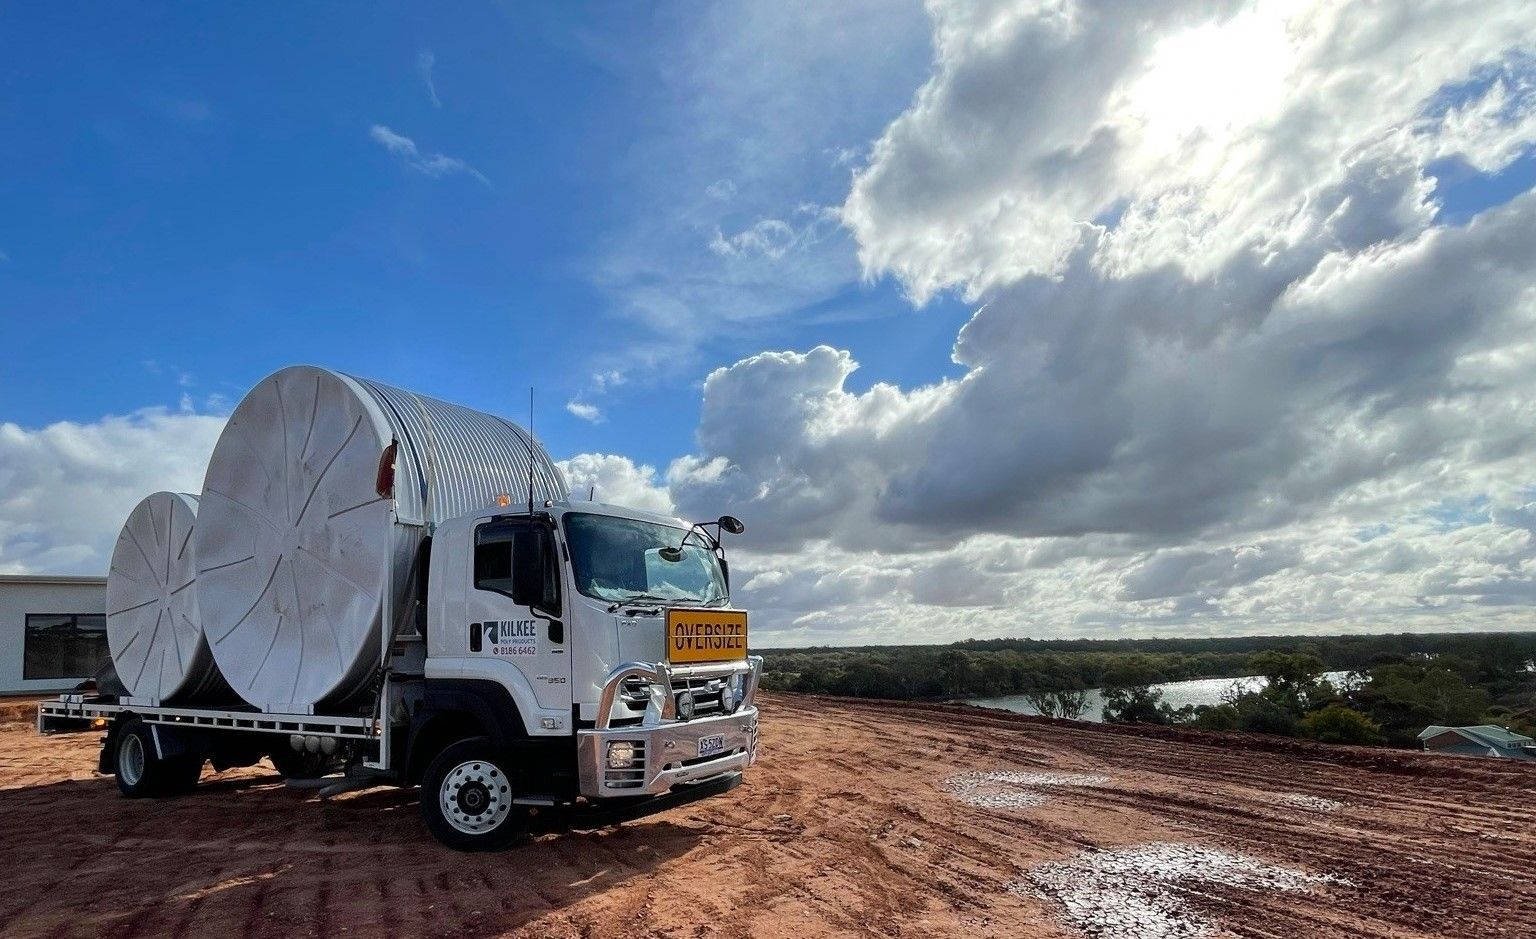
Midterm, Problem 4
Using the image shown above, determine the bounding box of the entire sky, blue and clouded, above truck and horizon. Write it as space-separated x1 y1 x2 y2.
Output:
0 0 1536 645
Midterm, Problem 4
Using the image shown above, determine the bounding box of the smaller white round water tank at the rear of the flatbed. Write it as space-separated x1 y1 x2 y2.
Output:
106 492 229 702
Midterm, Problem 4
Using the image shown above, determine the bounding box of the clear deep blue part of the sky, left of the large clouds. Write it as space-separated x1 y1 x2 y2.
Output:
0 5 963 463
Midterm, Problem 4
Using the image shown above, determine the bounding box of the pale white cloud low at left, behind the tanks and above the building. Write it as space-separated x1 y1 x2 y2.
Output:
0 409 224 575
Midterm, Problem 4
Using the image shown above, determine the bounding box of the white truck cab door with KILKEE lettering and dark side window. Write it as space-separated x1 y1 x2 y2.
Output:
464 518 571 715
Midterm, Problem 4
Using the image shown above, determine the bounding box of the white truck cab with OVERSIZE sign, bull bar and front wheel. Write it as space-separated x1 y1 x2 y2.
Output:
405 501 762 848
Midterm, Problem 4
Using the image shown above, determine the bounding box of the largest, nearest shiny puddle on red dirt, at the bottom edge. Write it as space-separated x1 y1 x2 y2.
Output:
1011 842 1336 939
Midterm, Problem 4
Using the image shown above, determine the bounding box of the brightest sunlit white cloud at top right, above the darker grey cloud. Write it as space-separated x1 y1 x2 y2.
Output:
843 0 1536 301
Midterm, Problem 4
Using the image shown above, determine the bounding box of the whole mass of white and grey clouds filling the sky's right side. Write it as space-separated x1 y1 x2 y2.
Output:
668 0 1536 642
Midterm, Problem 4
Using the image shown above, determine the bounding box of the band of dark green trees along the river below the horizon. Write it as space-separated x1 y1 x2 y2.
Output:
763 633 1536 745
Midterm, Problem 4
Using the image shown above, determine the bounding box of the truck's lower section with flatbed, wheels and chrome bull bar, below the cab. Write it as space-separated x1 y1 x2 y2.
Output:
37 656 762 850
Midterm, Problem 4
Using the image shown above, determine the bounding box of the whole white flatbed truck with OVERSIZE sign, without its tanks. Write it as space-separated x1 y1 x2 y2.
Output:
37 501 762 850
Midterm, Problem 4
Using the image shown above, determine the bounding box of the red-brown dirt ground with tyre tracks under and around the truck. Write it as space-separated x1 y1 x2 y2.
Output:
0 695 1536 939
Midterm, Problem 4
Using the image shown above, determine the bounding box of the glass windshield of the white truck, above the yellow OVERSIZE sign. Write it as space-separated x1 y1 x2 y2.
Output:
565 513 725 604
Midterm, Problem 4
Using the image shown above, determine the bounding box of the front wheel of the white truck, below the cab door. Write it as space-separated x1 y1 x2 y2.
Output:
421 736 528 851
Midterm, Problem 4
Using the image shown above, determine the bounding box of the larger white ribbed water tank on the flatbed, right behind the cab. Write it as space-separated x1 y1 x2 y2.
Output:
194 366 565 712
